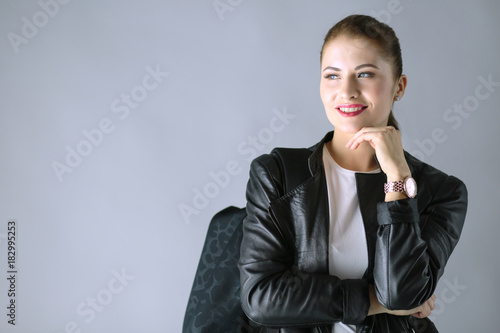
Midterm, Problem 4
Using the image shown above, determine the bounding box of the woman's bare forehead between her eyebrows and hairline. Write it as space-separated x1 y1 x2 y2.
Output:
322 35 390 68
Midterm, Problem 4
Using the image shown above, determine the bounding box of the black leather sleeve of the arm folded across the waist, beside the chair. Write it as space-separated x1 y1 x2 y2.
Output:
239 155 370 327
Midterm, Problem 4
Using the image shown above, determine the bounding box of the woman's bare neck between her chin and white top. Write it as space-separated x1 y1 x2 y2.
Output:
327 131 378 172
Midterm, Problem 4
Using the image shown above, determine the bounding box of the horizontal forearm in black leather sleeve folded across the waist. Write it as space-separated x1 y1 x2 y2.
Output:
241 266 369 327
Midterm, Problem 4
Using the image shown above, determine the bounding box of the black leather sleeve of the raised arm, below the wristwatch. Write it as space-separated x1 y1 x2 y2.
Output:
374 174 467 310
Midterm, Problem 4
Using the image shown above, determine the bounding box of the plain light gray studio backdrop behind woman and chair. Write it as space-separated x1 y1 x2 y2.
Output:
0 0 500 333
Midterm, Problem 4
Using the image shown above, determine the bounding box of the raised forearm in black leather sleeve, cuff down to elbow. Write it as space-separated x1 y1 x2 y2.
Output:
374 199 437 310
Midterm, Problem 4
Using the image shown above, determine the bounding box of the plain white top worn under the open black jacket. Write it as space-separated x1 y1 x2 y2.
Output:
323 145 380 333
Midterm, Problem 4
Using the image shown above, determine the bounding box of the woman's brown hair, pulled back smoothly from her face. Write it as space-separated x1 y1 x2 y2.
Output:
320 15 403 129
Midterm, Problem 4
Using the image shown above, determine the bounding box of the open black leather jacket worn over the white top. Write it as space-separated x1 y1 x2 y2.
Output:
239 132 467 333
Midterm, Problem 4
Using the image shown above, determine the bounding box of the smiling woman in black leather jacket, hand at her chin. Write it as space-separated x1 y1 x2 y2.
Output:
239 15 467 333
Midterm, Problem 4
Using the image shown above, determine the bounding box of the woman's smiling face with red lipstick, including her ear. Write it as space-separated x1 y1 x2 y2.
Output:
320 35 406 134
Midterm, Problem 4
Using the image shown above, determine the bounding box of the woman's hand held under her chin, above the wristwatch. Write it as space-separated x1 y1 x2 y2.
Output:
345 126 411 182
